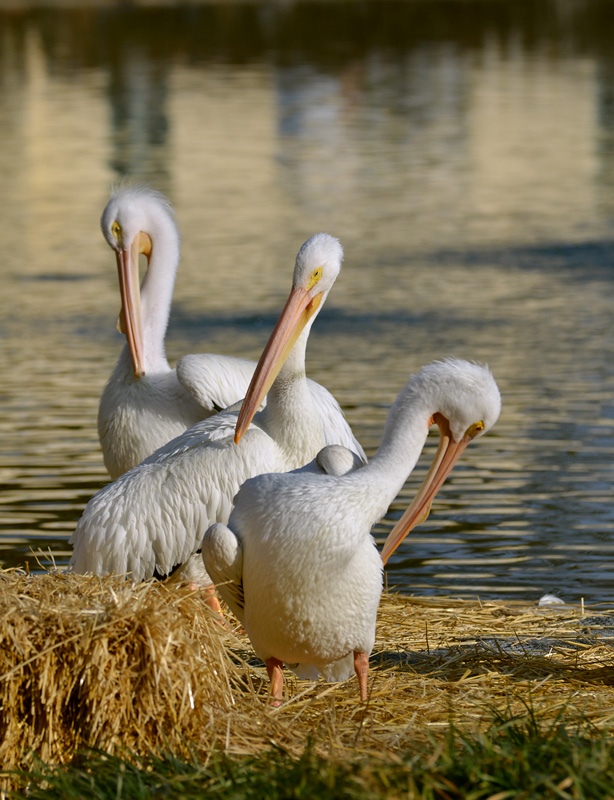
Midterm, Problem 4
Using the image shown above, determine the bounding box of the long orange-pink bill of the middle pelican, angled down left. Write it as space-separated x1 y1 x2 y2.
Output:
235 288 323 442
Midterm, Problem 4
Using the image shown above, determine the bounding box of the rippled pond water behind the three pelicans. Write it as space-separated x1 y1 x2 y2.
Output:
0 0 614 602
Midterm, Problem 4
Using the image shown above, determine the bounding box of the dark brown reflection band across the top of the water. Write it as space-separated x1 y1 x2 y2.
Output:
0 0 614 71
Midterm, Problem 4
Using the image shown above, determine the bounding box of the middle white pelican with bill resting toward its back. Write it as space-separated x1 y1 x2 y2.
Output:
70 233 364 584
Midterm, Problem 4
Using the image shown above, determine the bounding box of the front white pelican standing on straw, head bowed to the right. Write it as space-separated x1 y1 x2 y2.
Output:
202 359 501 702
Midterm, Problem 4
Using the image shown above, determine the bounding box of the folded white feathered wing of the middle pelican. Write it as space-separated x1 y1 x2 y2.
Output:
70 411 284 580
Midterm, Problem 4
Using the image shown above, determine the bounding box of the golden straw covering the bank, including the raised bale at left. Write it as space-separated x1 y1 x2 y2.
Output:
0 571 614 780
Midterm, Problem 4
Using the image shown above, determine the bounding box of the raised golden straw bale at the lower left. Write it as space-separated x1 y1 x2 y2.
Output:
0 571 250 767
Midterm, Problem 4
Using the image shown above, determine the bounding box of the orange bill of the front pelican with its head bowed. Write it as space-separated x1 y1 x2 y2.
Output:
382 432 474 564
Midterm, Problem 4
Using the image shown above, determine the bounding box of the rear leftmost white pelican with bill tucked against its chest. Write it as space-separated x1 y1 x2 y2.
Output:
98 187 255 479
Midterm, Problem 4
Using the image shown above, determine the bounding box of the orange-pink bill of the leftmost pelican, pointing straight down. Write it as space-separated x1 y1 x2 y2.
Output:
116 234 151 378
